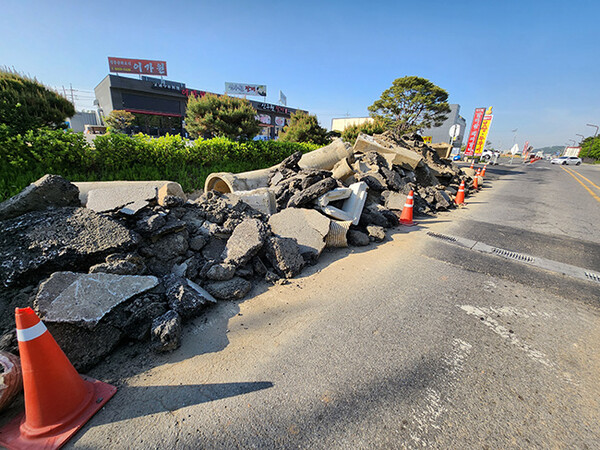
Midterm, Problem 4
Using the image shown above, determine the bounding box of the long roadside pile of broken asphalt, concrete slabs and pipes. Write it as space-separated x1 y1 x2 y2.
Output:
0 129 478 370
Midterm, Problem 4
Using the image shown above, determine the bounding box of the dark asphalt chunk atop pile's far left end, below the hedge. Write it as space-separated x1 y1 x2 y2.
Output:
0 175 80 220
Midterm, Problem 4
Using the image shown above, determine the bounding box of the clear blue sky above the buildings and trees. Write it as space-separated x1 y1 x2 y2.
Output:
0 0 600 148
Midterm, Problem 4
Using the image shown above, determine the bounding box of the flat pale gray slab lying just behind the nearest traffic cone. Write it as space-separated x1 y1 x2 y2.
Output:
35 272 158 328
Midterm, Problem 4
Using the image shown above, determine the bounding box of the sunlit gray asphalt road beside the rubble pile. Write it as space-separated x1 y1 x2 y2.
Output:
48 161 600 449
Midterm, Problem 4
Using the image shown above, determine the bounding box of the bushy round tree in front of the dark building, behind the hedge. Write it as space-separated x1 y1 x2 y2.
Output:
185 94 260 140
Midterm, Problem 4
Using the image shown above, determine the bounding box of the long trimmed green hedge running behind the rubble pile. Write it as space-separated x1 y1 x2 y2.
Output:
0 124 319 201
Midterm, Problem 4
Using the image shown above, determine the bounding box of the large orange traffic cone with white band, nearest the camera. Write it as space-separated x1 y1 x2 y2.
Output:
0 308 117 449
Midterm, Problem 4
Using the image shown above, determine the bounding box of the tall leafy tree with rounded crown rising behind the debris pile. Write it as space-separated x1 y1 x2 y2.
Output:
369 76 450 133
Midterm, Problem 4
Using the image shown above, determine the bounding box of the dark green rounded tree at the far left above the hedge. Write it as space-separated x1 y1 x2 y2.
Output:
0 69 75 134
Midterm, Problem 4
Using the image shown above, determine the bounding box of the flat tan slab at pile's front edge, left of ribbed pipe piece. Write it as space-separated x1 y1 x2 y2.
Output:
269 208 330 263
